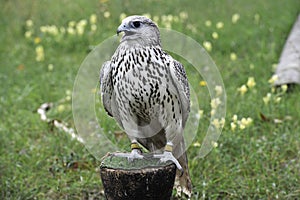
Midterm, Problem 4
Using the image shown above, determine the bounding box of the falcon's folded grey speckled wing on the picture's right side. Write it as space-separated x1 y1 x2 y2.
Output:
170 57 190 128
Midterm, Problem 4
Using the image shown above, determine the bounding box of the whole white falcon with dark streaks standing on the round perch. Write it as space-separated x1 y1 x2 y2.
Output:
100 15 192 196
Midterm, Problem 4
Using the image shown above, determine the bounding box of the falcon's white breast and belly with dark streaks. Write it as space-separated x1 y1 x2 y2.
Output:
111 47 178 125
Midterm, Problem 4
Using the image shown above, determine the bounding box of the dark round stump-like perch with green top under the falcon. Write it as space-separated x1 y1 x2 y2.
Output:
100 154 176 200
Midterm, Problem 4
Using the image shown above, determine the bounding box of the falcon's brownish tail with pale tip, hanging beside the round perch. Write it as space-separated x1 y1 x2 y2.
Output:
174 153 192 198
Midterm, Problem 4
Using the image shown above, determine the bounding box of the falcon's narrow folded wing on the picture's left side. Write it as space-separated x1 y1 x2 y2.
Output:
100 61 113 116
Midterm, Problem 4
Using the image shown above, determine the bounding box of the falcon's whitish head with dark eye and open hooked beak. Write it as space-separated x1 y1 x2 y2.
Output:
117 15 160 46
